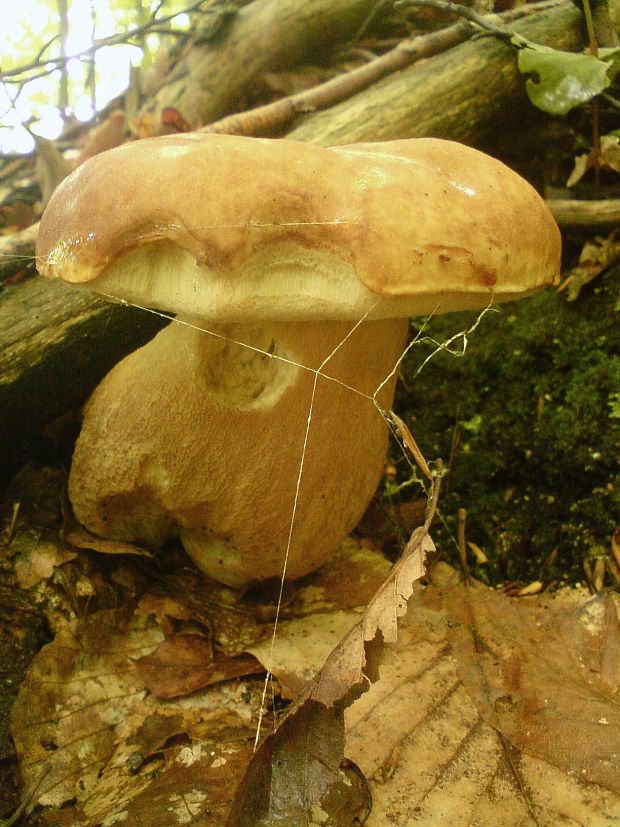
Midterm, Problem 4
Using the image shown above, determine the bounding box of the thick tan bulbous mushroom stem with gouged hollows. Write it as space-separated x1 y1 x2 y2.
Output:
69 319 407 586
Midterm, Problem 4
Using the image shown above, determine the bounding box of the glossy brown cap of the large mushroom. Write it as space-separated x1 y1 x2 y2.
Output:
37 134 560 322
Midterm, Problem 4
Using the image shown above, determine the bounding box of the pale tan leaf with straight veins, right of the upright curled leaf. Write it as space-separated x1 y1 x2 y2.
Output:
345 567 620 827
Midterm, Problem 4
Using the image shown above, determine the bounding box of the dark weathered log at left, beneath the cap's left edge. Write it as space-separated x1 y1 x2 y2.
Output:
0 278 163 483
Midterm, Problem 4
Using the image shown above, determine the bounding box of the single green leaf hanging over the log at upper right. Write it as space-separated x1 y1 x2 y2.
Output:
518 44 610 115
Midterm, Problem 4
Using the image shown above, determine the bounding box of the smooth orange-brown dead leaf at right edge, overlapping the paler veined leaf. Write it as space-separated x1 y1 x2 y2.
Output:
438 568 620 794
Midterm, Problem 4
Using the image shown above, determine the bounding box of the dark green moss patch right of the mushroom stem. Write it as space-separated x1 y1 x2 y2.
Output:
397 270 620 582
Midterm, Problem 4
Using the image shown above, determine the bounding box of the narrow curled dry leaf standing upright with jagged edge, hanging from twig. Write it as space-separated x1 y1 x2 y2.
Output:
227 525 434 827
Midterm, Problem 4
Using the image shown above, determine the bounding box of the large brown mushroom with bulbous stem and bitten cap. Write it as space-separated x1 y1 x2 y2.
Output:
37 133 560 586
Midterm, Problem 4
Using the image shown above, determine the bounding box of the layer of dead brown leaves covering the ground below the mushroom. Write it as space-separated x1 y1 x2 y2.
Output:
4 384 620 827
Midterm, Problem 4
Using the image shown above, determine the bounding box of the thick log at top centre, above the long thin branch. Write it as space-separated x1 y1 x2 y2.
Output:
141 0 376 134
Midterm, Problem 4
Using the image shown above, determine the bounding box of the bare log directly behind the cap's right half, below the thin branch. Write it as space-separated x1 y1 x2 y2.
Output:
287 0 620 146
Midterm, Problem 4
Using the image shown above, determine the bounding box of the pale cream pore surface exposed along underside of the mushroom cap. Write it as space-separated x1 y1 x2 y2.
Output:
80 242 534 323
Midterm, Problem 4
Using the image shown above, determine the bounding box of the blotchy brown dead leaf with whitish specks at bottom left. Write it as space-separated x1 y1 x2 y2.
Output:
12 608 257 827
